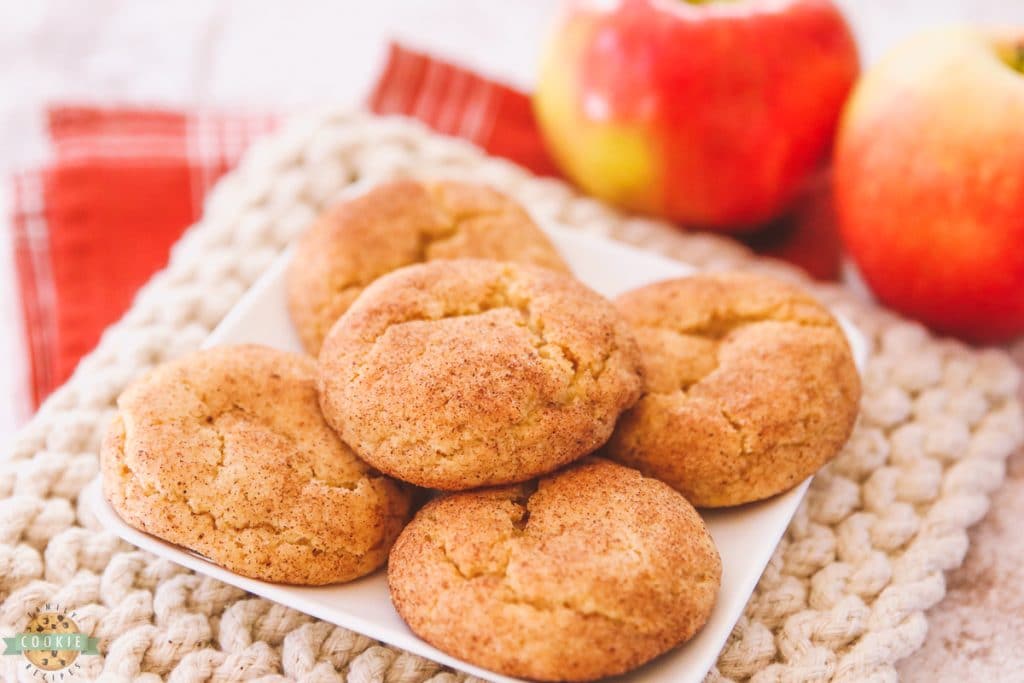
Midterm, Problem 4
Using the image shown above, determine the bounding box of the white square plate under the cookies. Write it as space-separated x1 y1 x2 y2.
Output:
83 193 867 683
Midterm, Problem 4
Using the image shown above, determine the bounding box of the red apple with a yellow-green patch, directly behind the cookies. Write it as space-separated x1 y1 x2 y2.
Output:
534 0 858 230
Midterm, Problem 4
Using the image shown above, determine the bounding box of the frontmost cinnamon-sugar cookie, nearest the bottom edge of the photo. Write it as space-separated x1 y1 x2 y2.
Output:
388 458 722 681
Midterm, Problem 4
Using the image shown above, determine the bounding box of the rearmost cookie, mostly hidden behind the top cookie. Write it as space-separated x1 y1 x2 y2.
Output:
288 180 568 354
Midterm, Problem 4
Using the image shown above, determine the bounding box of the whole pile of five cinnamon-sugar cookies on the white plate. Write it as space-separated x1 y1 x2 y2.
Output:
102 181 859 681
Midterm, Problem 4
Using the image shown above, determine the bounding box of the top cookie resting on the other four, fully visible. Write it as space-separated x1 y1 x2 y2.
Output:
319 259 642 490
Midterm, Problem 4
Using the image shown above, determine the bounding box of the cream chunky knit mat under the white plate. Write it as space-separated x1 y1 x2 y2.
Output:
0 111 1024 683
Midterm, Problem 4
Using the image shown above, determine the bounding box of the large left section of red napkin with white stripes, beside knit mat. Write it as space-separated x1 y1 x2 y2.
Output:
12 106 272 404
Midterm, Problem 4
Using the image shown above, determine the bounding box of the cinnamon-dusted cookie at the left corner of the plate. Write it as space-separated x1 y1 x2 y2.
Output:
101 346 410 585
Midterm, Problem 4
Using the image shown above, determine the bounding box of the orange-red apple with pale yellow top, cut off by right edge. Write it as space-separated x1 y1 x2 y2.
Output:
834 28 1024 341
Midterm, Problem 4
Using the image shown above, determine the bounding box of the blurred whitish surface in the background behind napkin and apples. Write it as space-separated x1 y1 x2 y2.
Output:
0 0 1024 675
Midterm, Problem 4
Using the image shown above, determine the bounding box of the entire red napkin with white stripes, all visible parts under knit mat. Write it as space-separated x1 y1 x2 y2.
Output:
12 45 839 417
